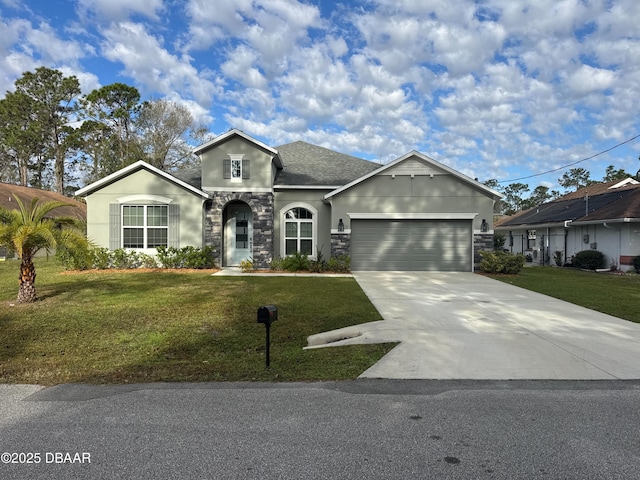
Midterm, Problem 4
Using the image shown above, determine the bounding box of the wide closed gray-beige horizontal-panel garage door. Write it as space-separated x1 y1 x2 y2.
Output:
351 220 473 272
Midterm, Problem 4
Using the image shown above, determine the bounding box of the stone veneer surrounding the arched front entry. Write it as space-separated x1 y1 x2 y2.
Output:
204 192 274 269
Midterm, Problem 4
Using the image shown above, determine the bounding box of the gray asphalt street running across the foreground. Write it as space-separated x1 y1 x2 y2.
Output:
0 379 640 480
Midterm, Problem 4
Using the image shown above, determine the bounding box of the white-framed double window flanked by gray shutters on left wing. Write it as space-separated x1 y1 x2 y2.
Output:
122 205 169 248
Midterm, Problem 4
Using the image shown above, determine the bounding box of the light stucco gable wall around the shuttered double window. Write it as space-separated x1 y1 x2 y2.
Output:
86 170 203 248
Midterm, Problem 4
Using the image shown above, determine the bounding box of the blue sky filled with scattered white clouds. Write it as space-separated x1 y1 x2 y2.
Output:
0 0 640 190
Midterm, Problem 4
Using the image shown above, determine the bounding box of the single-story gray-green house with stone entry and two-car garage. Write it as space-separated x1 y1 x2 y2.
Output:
77 129 500 271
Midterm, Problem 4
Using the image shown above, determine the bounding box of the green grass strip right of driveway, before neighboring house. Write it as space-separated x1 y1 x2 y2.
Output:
491 267 640 323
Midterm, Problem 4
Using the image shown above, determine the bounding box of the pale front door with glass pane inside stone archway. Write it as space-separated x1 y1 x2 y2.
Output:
225 203 253 267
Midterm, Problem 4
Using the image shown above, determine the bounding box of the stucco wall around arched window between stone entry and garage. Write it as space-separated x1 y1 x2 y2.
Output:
273 189 338 259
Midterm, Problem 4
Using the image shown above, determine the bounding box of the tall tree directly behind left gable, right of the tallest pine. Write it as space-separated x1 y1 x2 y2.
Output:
80 83 141 176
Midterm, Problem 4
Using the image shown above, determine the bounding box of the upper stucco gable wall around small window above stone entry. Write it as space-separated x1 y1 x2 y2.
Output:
200 136 275 192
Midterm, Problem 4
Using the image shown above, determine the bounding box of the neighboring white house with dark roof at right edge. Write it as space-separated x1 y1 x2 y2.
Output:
495 178 640 270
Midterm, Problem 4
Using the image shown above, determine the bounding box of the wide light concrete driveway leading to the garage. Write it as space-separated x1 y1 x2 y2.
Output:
309 272 640 380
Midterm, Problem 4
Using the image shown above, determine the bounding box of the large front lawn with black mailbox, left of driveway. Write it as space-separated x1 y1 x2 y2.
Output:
0 259 393 385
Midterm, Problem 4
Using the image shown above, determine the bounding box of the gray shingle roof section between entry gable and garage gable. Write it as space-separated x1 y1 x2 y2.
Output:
275 141 380 187
